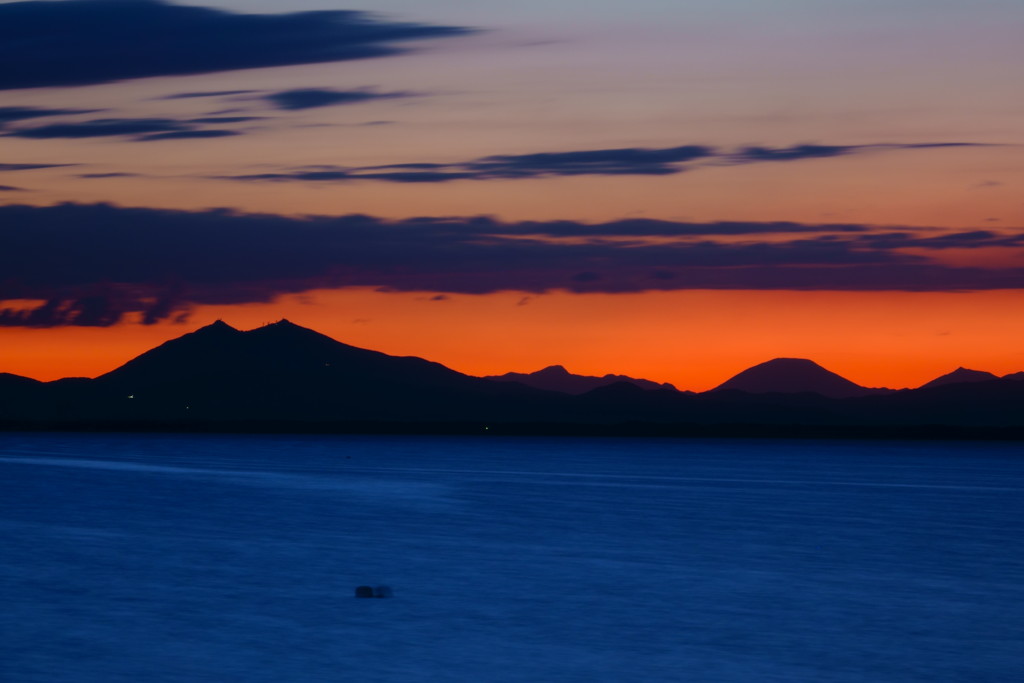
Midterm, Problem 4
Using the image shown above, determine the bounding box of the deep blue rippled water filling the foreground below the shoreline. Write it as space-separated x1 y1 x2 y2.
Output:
0 434 1024 683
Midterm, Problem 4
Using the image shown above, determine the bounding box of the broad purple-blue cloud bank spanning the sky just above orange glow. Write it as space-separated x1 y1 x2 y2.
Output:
0 204 1024 326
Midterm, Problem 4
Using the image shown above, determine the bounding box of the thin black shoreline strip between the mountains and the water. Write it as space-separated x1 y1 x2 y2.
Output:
0 420 1024 441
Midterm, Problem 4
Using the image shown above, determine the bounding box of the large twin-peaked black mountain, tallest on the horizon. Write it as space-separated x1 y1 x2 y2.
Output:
54 321 569 421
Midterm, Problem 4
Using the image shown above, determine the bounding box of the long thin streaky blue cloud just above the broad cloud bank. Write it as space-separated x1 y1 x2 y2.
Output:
226 142 987 182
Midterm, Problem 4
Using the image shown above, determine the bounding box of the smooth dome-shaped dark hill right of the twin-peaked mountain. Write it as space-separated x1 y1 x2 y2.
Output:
713 358 879 398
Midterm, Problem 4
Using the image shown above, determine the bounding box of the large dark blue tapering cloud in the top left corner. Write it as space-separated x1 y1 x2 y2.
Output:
0 0 468 90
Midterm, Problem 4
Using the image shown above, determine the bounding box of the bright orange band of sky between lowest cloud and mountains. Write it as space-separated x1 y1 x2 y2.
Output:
0 290 1024 391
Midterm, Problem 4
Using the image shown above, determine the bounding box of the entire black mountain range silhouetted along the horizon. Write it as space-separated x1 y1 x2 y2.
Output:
0 321 1024 438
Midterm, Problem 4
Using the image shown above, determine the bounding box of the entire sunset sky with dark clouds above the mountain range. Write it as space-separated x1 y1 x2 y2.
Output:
0 0 1024 390
